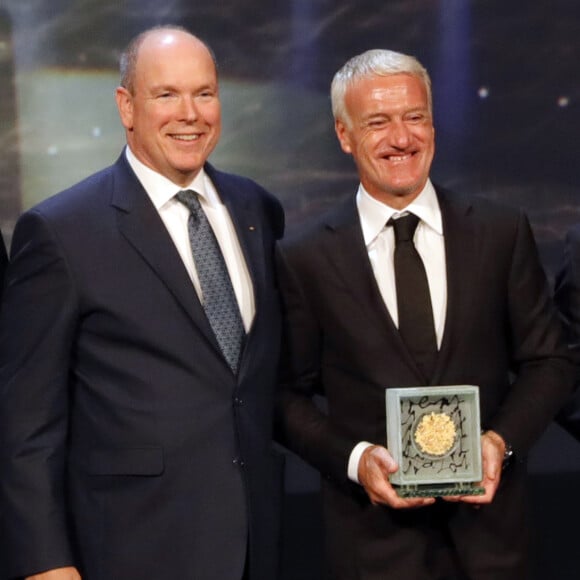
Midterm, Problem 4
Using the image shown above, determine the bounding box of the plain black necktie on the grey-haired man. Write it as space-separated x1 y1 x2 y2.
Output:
388 214 437 379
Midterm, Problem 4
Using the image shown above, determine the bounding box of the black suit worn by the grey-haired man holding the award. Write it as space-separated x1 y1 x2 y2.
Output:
279 190 572 580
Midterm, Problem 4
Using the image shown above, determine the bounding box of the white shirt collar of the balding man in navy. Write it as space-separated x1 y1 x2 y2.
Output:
125 145 219 210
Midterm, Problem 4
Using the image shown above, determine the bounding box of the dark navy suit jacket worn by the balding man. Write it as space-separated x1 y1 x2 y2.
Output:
0 155 283 580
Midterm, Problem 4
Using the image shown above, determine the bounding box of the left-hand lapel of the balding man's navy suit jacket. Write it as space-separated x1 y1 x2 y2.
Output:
111 154 220 352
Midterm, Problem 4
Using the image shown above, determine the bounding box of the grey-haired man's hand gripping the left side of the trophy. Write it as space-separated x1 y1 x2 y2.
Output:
358 445 435 509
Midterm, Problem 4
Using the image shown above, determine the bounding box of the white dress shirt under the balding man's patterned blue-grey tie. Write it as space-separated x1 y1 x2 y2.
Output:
125 146 256 332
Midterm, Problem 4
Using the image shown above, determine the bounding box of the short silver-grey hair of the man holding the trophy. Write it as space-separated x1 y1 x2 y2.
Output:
330 49 433 125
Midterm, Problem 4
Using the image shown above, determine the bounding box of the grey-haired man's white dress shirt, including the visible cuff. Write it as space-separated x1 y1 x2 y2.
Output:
348 180 447 482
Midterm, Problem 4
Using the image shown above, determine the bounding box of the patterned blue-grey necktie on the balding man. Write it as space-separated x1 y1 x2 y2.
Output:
175 190 245 374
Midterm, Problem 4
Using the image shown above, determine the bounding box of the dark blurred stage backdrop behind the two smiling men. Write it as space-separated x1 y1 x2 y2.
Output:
0 0 580 580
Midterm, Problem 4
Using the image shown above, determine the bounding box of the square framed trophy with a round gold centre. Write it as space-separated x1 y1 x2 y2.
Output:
385 385 484 497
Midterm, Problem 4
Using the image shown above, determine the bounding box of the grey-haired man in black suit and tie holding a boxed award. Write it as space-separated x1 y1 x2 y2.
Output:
279 50 572 580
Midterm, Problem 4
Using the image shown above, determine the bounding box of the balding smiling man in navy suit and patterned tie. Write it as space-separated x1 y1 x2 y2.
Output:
0 27 283 580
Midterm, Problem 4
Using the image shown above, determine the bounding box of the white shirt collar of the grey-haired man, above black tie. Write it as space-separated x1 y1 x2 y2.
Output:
356 179 443 246
